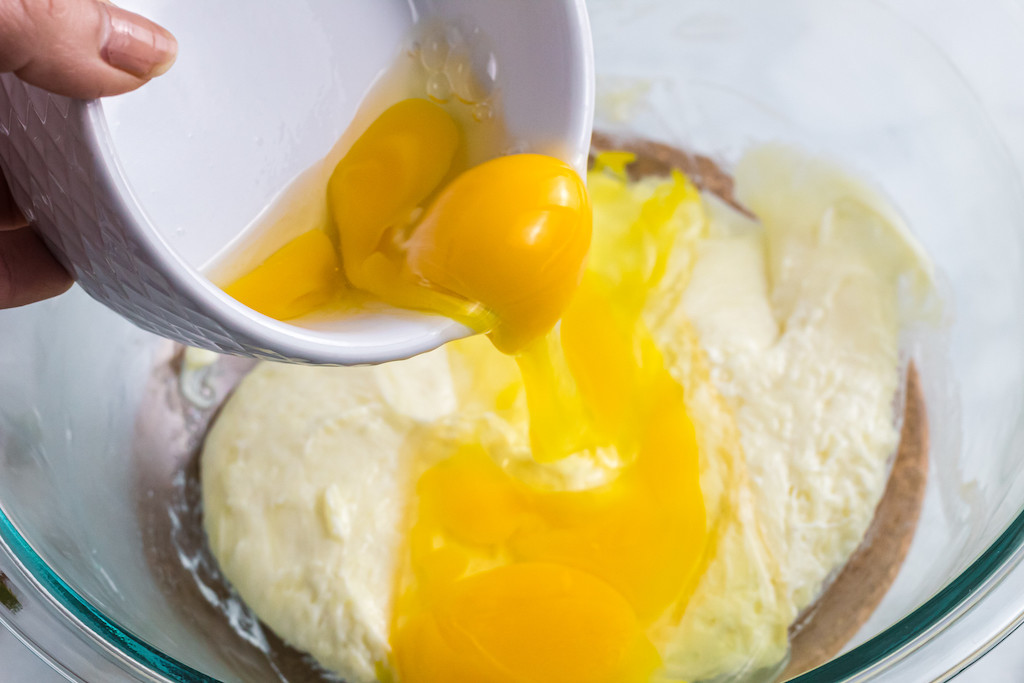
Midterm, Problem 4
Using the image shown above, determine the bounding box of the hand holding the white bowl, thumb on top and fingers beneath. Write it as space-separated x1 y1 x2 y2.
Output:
0 0 177 308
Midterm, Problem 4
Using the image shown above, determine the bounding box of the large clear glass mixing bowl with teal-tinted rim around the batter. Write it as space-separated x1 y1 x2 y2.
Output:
0 0 1024 683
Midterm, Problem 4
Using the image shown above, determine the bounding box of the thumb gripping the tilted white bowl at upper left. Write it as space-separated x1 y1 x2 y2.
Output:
0 0 177 98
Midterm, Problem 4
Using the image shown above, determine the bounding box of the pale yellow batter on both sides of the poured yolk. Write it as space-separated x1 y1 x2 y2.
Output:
203 147 931 683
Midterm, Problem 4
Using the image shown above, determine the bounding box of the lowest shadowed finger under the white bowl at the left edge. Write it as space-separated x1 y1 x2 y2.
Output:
0 227 73 308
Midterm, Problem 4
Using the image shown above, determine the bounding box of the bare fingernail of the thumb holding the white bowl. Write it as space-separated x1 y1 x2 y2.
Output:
99 3 178 78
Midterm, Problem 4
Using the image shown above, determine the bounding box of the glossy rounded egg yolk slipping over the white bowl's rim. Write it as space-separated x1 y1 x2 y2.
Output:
408 155 591 351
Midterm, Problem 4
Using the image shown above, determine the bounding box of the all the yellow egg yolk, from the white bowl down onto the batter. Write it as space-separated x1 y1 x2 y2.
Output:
221 22 709 683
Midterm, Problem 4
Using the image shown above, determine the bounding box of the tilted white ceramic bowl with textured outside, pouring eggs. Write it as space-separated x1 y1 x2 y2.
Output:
0 0 594 365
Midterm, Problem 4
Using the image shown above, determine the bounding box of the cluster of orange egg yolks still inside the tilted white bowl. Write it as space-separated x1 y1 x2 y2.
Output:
226 98 591 351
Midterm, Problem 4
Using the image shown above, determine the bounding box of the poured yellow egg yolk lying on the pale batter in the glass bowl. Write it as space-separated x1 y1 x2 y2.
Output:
392 161 710 683
